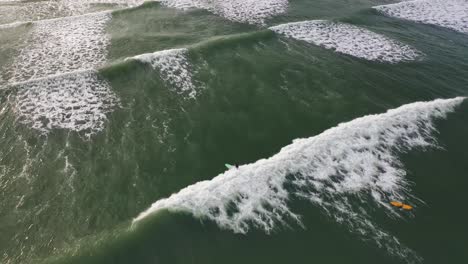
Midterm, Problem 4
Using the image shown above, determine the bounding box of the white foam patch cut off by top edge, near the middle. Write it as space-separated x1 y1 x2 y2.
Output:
160 0 288 25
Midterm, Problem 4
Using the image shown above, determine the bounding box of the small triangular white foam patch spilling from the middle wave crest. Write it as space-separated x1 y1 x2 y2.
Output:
130 49 197 97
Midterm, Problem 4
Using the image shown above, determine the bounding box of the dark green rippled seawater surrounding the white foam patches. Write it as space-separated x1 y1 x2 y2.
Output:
0 0 468 264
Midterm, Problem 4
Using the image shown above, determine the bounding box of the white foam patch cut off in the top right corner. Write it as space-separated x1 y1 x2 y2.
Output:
374 0 468 33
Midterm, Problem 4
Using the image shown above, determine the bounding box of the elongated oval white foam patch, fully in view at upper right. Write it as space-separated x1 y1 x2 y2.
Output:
270 20 421 63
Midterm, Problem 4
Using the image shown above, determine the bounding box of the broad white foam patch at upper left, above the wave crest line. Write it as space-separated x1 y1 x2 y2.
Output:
6 12 111 82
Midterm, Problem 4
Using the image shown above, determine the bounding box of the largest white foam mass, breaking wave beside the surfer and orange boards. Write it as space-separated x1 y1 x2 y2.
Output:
133 97 464 259
